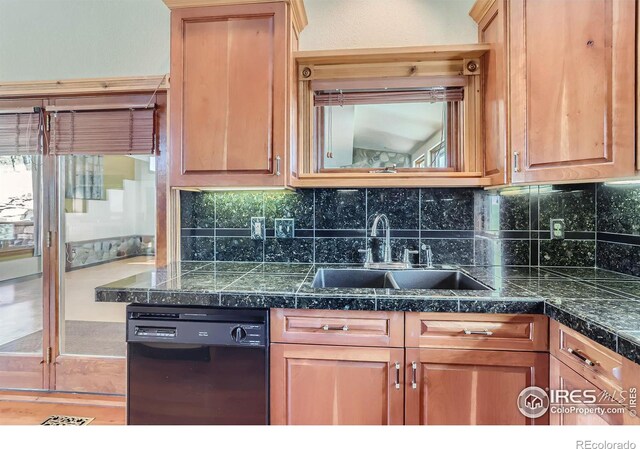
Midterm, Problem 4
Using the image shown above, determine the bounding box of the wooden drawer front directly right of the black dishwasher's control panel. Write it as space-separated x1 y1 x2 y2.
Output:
271 309 404 347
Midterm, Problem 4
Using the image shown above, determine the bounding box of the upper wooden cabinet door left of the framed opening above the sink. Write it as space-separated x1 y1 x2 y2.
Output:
170 2 289 186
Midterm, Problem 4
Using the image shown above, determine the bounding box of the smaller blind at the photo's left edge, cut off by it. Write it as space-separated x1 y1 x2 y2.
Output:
0 108 40 155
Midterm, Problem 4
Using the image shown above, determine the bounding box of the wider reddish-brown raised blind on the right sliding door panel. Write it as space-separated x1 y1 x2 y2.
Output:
47 105 156 155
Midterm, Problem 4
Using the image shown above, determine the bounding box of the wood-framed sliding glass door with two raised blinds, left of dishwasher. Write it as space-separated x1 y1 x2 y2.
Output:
0 94 165 394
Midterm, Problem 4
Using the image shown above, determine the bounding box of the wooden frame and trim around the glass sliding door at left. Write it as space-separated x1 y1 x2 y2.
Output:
0 75 171 394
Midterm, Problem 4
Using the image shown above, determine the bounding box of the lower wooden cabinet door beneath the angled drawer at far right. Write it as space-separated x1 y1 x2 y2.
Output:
550 356 624 426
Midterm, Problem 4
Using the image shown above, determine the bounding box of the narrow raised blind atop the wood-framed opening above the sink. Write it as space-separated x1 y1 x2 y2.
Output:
314 87 464 106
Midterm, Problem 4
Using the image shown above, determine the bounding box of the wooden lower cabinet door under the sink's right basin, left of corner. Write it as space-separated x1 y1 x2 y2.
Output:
405 348 549 425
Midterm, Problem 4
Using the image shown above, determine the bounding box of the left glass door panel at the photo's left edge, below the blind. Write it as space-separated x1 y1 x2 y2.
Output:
0 153 45 389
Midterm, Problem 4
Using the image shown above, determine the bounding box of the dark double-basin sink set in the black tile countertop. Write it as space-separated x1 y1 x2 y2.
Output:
311 268 491 290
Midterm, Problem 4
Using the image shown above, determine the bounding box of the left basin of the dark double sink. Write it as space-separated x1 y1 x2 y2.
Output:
311 268 397 288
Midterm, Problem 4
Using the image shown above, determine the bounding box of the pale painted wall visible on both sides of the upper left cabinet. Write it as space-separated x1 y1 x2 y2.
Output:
0 0 477 81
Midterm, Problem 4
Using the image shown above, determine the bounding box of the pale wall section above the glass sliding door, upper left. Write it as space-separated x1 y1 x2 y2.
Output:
0 0 169 81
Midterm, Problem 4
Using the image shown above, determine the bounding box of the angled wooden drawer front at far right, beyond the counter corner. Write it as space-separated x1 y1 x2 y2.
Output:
550 320 622 395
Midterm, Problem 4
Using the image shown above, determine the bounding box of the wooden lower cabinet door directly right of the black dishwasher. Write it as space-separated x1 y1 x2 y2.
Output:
271 344 404 425
